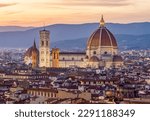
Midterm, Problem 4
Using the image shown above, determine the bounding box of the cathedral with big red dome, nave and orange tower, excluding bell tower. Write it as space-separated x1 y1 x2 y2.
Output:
50 16 123 68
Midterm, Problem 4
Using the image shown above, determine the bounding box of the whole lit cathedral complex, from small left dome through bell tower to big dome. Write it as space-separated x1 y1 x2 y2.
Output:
24 16 123 68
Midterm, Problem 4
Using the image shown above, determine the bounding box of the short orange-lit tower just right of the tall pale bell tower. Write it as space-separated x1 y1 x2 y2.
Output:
52 48 59 68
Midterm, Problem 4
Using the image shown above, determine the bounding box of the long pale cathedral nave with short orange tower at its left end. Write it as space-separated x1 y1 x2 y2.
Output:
50 48 86 68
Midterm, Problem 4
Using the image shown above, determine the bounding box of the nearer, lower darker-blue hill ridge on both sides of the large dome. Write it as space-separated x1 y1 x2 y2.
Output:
51 34 150 50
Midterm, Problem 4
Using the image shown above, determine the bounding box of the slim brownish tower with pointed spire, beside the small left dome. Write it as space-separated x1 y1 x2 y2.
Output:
32 40 39 68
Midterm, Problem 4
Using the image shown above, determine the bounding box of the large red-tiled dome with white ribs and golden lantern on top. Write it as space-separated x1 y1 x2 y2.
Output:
87 16 117 49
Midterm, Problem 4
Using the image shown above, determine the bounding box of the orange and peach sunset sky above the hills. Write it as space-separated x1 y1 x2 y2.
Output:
0 0 150 26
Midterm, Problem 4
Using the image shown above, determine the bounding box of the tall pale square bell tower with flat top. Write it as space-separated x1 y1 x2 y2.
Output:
39 29 50 67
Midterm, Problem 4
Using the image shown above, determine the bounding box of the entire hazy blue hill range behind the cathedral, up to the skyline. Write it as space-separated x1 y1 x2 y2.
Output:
0 22 150 49
